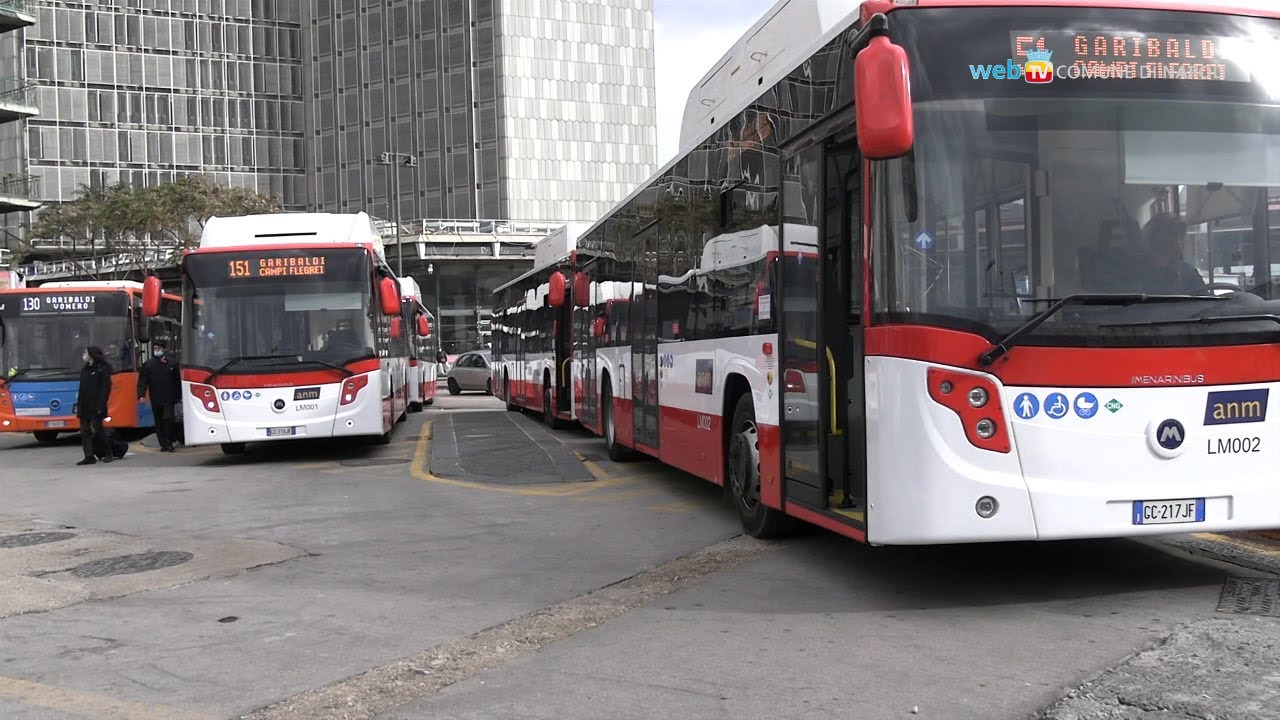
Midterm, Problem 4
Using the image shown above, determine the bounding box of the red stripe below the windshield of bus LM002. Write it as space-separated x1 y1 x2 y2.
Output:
865 325 1280 387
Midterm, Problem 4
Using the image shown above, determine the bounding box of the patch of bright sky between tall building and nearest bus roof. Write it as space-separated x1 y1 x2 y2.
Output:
653 0 776 168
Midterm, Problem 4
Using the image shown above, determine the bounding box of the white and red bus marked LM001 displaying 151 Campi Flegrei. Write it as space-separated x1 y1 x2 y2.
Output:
143 213 410 455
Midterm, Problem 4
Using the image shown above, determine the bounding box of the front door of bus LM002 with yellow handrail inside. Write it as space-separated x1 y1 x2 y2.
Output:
781 141 867 528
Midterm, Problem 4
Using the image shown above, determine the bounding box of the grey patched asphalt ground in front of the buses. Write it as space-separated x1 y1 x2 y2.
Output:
0 395 1280 720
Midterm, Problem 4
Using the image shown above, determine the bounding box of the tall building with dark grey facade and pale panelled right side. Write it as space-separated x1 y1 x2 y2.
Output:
303 0 657 222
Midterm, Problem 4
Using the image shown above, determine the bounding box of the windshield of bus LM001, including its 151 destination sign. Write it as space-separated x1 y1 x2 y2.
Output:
183 249 375 373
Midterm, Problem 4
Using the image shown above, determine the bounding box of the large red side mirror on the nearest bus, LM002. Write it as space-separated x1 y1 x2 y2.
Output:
854 36 915 160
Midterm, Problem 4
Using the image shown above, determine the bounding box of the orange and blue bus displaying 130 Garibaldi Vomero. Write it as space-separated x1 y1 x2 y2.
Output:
0 281 182 445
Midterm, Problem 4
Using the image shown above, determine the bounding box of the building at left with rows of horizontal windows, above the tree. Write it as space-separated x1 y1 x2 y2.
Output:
4 0 307 209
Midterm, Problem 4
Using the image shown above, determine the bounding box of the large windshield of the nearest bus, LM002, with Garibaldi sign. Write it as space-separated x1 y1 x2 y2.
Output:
873 8 1280 346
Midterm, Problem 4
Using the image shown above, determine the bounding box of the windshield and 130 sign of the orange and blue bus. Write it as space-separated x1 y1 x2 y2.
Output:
0 292 137 380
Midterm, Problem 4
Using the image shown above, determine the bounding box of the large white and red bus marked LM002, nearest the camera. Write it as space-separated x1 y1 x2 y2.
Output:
495 0 1280 544
